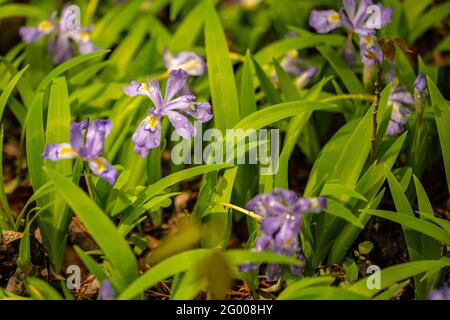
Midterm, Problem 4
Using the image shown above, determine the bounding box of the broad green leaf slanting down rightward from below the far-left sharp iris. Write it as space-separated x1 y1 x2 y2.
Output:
44 168 138 291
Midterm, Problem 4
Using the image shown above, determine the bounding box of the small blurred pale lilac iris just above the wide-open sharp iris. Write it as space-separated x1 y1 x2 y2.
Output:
163 50 206 76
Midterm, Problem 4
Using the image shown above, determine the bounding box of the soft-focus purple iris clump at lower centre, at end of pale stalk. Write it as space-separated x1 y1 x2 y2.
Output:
239 188 326 281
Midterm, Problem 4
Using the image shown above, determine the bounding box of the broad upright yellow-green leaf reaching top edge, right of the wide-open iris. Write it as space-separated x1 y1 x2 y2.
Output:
204 0 239 132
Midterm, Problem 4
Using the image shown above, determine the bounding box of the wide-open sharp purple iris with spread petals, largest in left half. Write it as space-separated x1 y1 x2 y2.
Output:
123 69 213 157
